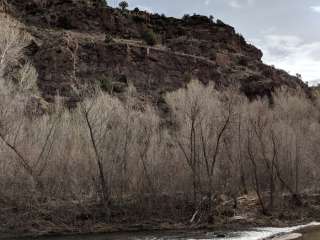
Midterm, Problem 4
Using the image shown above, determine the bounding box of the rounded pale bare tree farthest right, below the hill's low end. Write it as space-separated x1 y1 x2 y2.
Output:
274 89 319 204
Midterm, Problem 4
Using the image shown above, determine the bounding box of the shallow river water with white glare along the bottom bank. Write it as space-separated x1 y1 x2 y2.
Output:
8 222 320 240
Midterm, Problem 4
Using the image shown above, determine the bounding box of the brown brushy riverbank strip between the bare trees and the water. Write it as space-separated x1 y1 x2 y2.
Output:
0 195 320 239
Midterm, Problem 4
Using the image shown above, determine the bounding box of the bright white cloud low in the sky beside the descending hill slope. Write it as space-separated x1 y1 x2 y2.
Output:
252 34 320 84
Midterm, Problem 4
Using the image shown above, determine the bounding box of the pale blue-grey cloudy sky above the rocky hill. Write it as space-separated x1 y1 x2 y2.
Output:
109 0 320 84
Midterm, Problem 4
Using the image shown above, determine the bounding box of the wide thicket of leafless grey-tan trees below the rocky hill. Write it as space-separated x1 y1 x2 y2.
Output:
0 15 320 224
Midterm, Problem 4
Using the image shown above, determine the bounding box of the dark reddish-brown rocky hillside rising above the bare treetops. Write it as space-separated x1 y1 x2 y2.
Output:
0 0 308 106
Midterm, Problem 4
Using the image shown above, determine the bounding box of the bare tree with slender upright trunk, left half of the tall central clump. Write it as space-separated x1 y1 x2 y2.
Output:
166 80 214 209
